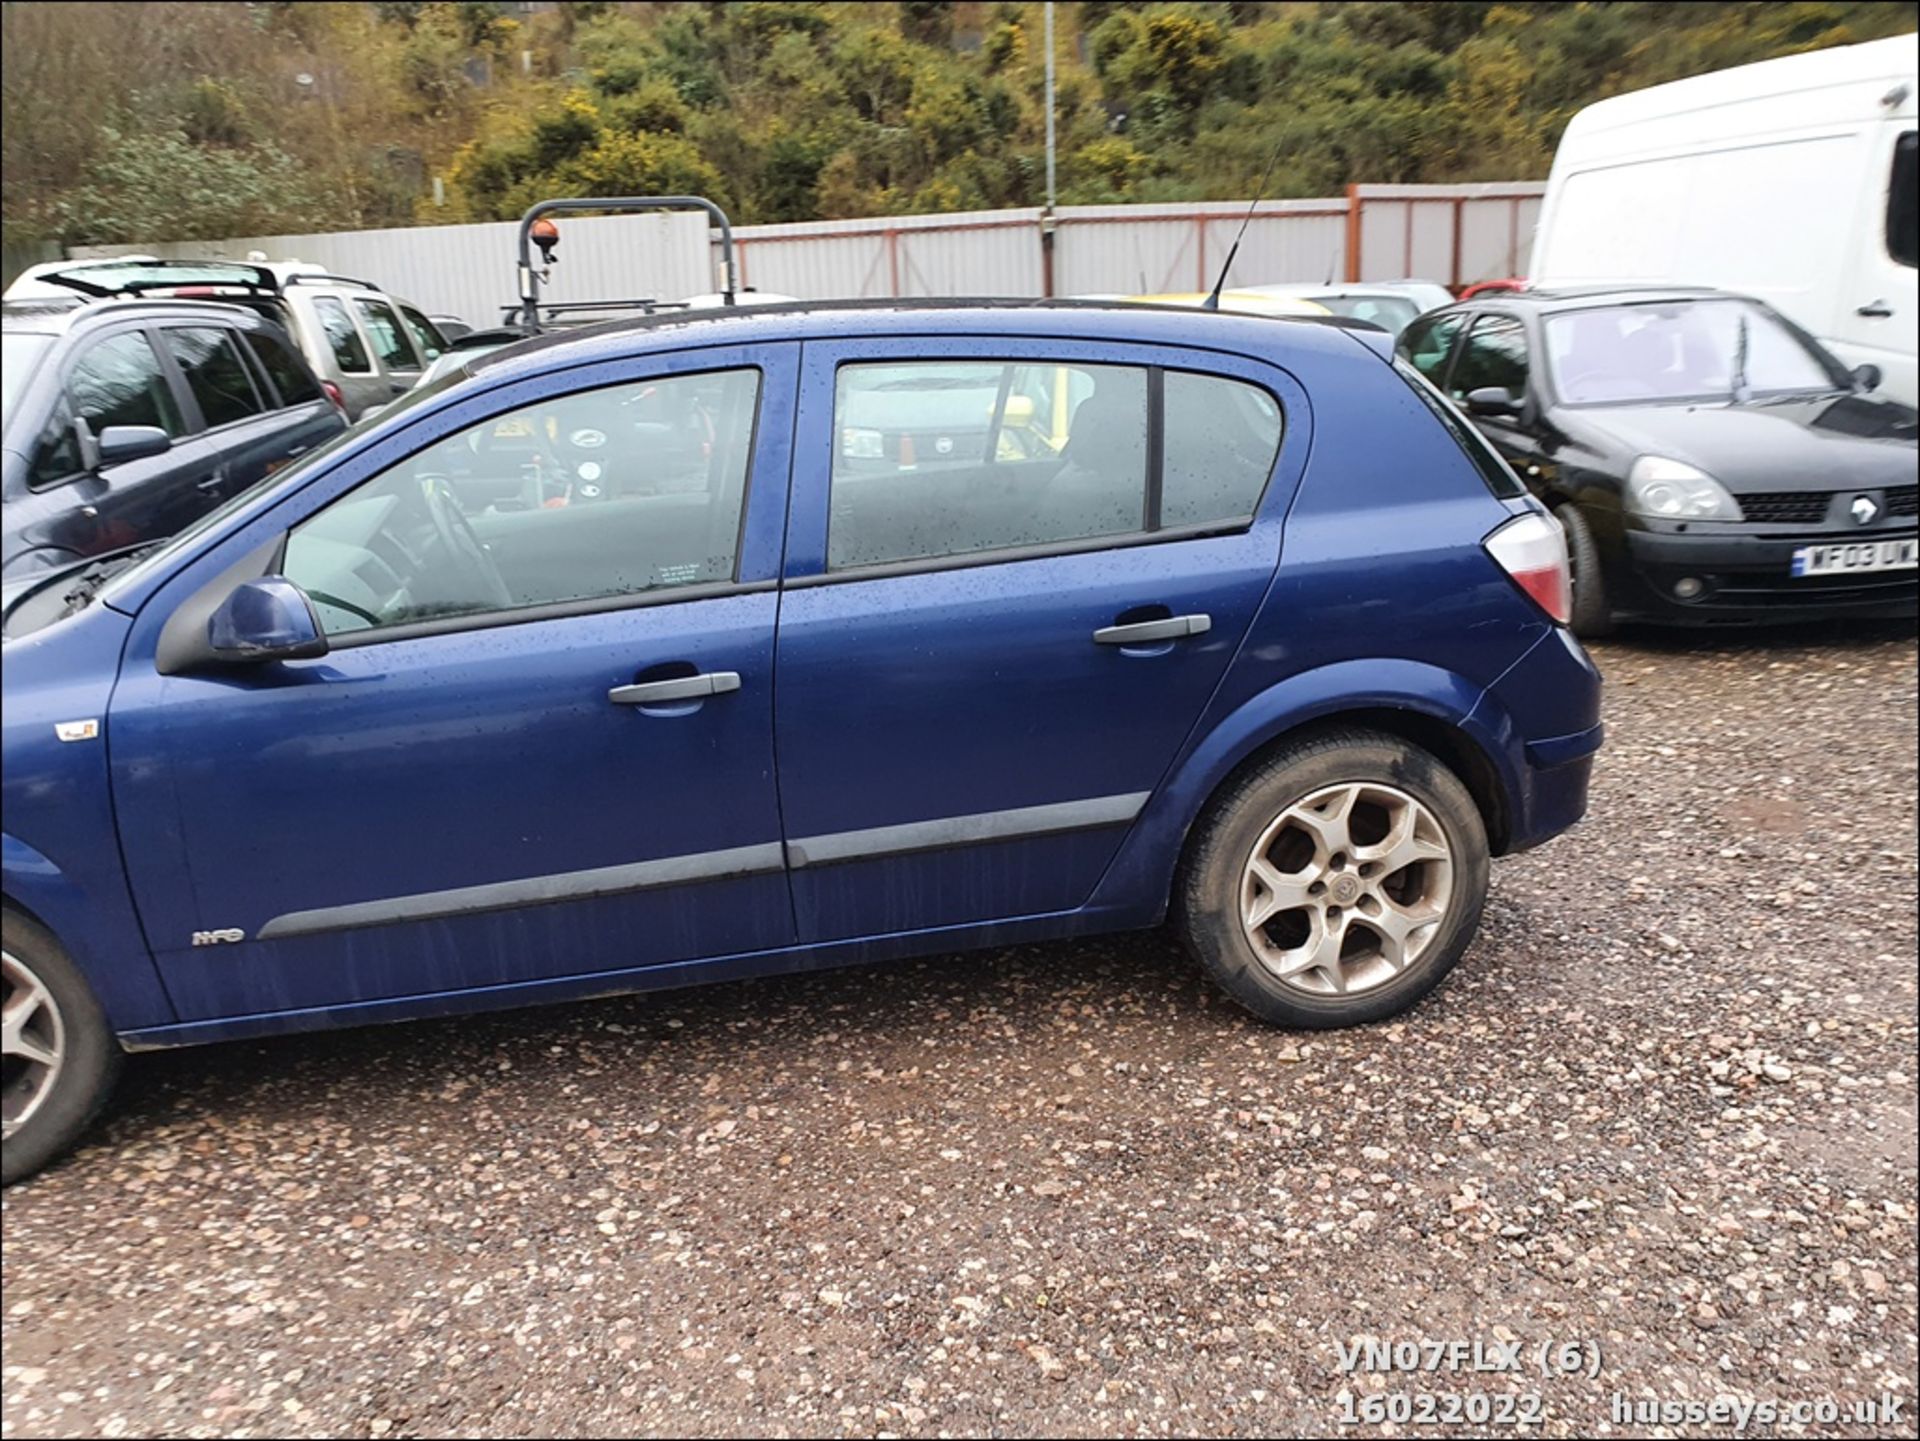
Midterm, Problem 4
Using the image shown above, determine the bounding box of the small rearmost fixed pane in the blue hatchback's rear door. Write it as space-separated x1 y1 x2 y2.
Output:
1160 370 1281 526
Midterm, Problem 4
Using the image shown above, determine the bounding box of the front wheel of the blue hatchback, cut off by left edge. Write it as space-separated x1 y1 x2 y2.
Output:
0 909 121 1186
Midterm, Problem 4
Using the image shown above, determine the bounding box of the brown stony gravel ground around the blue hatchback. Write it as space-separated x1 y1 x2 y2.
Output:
0 627 1920 1437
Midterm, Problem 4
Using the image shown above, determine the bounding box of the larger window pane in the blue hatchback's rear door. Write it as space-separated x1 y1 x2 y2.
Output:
828 361 1146 570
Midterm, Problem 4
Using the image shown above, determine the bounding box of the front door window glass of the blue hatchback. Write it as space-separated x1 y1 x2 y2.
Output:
284 370 760 635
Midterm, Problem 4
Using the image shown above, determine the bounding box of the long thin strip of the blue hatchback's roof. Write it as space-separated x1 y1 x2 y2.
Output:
468 297 1386 376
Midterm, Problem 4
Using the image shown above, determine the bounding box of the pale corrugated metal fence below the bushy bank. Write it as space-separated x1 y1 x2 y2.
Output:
75 182 1546 322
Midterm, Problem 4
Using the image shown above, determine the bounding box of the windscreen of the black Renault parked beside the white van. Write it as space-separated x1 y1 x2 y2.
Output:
1546 297 1847 405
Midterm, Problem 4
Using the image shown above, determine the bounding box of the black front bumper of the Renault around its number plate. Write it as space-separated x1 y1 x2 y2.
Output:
1609 524 1920 626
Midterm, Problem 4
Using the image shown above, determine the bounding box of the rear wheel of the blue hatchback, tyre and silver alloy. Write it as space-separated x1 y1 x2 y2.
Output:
1175 729 1490 1028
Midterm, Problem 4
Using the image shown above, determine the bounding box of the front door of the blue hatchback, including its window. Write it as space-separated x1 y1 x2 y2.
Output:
111 345 797 1021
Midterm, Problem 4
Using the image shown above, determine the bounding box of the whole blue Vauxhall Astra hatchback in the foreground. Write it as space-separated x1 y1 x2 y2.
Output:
4 301 1601 1180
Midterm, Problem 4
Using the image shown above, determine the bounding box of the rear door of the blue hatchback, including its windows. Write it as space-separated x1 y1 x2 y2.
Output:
776 338 1308 940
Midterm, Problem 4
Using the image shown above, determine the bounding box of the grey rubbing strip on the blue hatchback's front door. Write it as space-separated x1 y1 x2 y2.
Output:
257 840 783 940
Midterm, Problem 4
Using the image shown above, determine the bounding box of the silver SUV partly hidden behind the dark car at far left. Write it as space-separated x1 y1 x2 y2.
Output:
6 257 447 420
